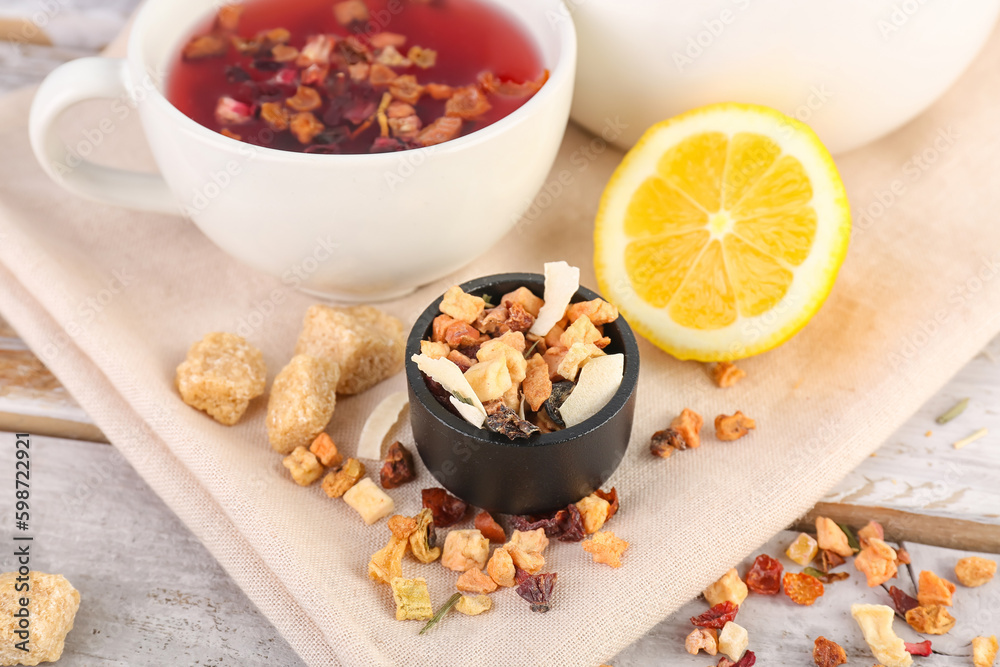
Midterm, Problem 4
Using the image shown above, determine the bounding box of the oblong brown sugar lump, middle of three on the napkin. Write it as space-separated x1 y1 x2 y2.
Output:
267 354 340 454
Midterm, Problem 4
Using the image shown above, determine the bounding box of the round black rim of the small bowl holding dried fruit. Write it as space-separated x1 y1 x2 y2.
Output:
404 273 640 449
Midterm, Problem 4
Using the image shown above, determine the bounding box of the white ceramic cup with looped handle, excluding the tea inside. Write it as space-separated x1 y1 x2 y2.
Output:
30 0 576 301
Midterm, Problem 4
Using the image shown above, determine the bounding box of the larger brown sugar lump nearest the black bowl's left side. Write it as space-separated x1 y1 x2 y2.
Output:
295 304 406 394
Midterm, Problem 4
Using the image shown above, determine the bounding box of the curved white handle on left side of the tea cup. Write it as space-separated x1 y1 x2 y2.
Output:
28 58 180 215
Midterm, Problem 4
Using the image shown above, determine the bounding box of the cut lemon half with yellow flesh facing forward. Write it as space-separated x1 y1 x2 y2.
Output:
594 103 851 361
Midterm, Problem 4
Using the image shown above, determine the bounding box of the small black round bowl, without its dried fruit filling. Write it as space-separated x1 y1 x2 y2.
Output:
406 273 639 514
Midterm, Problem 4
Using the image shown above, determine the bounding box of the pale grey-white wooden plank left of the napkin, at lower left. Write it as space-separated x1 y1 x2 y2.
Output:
0 433 303 667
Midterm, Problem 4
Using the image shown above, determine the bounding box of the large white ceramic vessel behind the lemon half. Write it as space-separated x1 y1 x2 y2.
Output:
568 0 1000 153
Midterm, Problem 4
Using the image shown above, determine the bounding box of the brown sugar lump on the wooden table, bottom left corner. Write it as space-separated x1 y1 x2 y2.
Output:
0 572 80 665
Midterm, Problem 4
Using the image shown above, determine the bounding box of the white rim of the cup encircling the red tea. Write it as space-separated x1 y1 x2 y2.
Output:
126 0 577 165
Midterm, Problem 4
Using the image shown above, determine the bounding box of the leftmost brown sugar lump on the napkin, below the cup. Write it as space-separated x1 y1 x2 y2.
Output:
176 332 267 426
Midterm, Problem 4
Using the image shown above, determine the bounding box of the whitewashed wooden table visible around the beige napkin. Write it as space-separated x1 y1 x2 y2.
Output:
0 9 1000 667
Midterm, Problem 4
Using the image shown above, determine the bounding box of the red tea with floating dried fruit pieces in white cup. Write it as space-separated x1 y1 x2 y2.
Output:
167 0 548 153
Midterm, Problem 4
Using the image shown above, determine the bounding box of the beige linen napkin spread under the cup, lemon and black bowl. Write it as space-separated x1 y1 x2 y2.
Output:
0 15 1000 667
